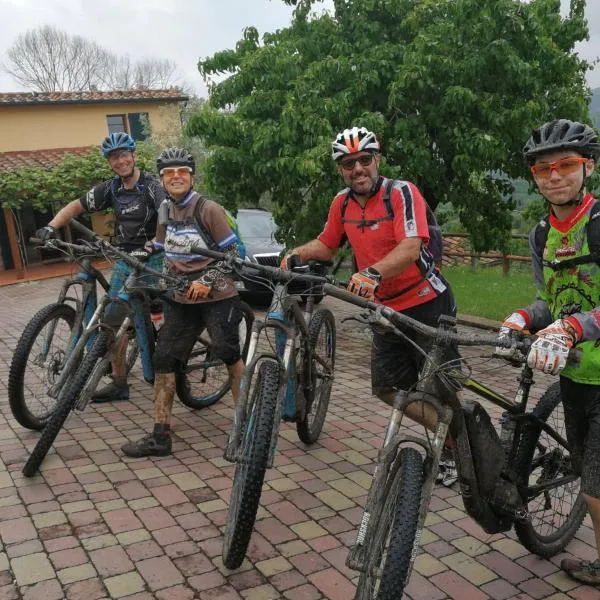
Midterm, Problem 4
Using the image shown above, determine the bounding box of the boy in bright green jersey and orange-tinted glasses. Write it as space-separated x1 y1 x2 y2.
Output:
497 119 600 585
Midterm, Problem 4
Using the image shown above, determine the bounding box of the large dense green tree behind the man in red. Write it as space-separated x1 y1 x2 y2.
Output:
188 0 589 250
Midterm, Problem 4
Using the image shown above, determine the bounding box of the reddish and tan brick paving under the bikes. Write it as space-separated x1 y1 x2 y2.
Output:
0 279 600 600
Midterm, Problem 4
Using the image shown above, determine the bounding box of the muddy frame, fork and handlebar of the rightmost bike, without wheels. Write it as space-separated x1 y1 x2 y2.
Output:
324 285 578 581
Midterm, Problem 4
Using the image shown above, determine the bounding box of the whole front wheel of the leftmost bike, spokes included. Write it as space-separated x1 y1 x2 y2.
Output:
8 304 76 430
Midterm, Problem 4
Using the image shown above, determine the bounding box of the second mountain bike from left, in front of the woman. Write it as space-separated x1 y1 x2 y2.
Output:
23 226 253 477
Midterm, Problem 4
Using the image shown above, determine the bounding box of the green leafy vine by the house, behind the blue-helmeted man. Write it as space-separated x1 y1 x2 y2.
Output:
0 143 156 210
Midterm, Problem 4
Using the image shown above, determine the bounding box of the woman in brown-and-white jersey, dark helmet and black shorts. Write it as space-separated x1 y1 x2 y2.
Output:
122 148 244 457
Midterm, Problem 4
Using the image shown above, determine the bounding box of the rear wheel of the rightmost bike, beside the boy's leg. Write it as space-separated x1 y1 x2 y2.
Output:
515 382 587 558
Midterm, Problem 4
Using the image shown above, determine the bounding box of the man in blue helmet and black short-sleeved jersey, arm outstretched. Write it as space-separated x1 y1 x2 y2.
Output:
36 132 165 402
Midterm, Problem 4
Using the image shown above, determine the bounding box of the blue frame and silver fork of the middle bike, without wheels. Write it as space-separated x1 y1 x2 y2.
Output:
224 276 314 468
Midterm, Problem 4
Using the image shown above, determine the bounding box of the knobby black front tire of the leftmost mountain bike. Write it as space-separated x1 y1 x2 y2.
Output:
8 303 76 431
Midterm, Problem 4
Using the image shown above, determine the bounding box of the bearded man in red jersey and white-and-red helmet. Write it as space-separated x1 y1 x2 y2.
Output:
282 127 458 476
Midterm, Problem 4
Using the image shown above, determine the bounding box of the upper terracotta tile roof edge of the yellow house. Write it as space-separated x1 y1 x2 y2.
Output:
0 88 188 107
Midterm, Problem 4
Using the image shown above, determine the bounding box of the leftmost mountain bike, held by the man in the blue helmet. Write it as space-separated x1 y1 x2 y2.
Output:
8 227 253 430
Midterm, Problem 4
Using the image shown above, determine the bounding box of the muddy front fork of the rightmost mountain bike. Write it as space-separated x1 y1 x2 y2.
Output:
346 391 452 580
